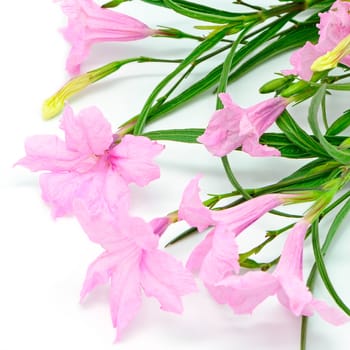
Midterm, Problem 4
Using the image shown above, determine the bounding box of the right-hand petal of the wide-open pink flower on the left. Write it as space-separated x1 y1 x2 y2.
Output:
110 135 164 186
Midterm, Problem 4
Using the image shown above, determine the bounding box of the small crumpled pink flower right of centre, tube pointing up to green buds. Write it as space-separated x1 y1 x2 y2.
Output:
198 93 288 157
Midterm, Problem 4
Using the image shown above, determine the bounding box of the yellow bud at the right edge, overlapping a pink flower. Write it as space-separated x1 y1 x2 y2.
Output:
311 35 350 72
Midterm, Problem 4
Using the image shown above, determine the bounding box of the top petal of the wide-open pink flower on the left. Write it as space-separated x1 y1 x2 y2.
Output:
61 106 113 155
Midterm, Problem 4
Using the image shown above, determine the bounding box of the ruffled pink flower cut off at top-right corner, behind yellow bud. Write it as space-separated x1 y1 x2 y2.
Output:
283 0 350 80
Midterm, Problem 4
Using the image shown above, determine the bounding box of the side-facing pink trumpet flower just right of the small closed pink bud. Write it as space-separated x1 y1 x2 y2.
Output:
178 176 290 285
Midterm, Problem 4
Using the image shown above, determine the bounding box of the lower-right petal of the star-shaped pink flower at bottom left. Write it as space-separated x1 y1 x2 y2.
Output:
141 250 197 313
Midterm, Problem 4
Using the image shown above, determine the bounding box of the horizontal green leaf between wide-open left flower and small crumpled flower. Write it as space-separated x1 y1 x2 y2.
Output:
142 128 205 143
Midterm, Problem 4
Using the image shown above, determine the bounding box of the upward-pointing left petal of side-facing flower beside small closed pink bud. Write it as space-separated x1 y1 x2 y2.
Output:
178 176 213 232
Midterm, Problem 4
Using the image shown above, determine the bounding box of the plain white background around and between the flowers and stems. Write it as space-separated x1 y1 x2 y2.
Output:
0 0 350 350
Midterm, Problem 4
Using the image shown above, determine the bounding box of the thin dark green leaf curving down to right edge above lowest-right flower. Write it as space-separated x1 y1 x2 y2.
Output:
311 219 350 316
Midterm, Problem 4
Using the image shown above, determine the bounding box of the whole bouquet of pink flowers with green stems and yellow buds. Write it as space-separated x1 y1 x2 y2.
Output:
17 0 350 349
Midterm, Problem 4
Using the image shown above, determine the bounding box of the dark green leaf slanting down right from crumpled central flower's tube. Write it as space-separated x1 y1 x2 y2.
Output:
276 110 328 157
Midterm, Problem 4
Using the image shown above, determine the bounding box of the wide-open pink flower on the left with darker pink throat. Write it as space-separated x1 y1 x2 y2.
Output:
17 106 163 217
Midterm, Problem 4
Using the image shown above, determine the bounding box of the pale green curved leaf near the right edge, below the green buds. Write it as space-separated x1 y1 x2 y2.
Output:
308 85 350 164
